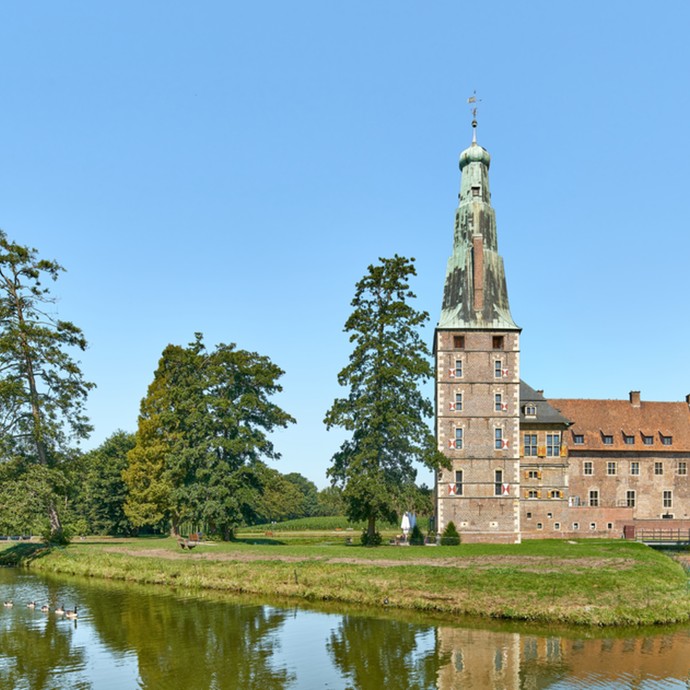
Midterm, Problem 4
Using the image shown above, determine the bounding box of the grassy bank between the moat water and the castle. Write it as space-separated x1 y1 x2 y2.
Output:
5 533 690 625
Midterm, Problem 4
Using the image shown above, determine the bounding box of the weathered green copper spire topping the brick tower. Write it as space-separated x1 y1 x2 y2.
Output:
438 120 518 329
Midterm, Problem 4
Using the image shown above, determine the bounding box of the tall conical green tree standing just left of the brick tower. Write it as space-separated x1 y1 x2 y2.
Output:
324 255 447 543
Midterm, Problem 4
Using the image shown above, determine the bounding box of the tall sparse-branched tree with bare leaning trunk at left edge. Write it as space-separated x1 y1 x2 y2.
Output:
0 231 93 540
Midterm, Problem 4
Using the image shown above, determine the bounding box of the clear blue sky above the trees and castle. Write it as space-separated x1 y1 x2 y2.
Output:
0 0 690 486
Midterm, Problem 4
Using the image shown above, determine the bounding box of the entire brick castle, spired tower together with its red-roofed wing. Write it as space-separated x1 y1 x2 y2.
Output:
434 120 690 543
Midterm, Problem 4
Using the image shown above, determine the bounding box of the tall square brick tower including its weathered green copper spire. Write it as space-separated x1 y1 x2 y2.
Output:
434 115 520 543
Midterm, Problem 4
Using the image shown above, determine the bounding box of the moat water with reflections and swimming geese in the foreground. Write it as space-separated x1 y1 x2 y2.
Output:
0 569 690 690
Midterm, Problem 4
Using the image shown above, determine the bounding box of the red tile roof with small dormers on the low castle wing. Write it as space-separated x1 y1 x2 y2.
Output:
549 398 690 453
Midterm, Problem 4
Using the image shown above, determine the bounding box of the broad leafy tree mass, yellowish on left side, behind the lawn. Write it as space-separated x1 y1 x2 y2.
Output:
123 333 294 539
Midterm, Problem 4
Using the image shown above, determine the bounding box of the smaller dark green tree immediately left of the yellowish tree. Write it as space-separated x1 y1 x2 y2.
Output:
79 431 134 536
